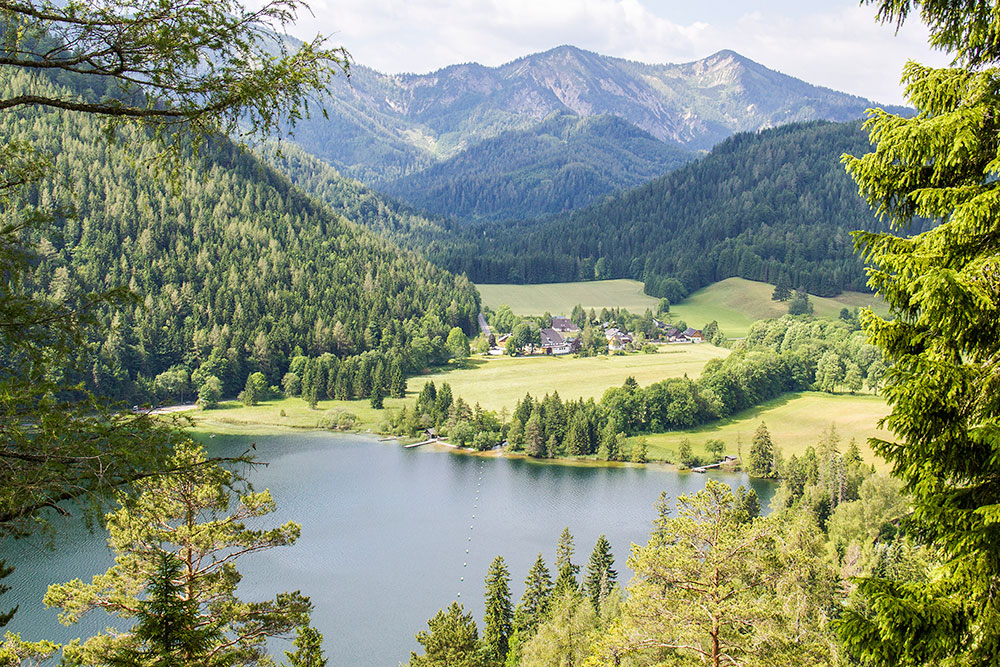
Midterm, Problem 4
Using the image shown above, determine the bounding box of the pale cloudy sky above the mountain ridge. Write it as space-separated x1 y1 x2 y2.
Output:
272 0 950 104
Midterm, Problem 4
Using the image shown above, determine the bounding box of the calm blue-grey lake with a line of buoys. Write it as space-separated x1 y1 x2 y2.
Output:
0 432 773 667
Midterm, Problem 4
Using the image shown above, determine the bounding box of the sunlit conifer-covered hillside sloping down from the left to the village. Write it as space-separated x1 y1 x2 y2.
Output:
0 71 478 398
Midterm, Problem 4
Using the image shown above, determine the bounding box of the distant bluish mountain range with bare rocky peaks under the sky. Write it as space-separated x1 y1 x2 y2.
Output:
296 46 912 186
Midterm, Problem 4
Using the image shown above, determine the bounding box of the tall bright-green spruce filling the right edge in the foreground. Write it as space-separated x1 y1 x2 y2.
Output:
838 0 1000 665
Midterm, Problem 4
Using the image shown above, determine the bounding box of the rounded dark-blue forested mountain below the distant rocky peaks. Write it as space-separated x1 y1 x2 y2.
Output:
380 112 696 221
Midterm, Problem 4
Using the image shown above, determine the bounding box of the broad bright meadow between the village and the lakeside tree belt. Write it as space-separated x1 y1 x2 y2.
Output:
407 343 729 410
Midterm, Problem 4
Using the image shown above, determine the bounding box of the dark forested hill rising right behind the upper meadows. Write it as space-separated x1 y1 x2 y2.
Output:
434 122 916 301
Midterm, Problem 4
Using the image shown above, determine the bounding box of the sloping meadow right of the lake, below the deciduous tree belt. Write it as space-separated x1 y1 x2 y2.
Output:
632 391 890 470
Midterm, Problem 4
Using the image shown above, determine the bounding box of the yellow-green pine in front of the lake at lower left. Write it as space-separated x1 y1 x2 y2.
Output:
45 442 312 664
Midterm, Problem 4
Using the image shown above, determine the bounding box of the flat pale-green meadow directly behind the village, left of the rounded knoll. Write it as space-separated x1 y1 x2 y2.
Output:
476 280 660 315
